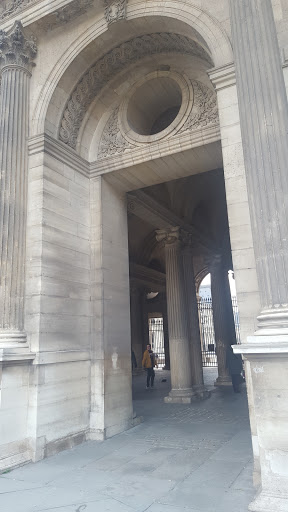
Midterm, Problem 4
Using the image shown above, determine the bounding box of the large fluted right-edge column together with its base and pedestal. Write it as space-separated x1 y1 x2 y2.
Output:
230 0 288 512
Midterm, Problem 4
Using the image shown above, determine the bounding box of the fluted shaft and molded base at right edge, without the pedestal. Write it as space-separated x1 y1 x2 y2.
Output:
231 0 288 335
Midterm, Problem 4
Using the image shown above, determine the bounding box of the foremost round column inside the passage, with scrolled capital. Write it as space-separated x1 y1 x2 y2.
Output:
157 227 194 403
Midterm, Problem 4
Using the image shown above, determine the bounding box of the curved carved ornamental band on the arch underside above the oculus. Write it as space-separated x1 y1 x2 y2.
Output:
59 32 212 148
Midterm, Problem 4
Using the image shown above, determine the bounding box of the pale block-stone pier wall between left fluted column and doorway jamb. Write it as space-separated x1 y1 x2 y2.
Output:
26 148 91 459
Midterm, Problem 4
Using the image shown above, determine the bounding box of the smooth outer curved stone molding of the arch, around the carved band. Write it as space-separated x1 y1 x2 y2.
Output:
31 0 233 136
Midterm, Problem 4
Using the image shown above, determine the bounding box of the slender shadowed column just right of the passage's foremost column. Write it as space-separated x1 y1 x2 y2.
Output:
182 234 210 399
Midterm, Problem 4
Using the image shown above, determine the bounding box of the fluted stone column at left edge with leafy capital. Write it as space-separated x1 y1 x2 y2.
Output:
0 22 37 348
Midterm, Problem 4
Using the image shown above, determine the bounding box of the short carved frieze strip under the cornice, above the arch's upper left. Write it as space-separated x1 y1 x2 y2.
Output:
41 0 94 32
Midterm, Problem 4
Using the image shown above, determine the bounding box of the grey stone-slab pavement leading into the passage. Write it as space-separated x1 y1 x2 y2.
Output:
0 369 254 512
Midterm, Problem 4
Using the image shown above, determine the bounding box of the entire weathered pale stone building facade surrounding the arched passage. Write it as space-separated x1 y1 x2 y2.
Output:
0 0 288 512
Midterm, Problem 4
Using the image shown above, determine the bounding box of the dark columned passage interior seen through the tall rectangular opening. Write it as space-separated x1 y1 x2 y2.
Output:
128 171 240 403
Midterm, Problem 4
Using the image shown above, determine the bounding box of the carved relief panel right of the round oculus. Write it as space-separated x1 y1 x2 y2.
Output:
178 80 218 133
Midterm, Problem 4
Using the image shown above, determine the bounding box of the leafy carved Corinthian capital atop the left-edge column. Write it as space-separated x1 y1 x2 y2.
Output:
0 21 37 71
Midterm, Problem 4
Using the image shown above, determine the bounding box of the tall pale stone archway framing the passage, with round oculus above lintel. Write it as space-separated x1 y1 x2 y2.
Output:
0 2 256 480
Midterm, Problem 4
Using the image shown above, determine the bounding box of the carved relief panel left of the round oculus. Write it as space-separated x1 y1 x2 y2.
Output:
98 107 133 159
